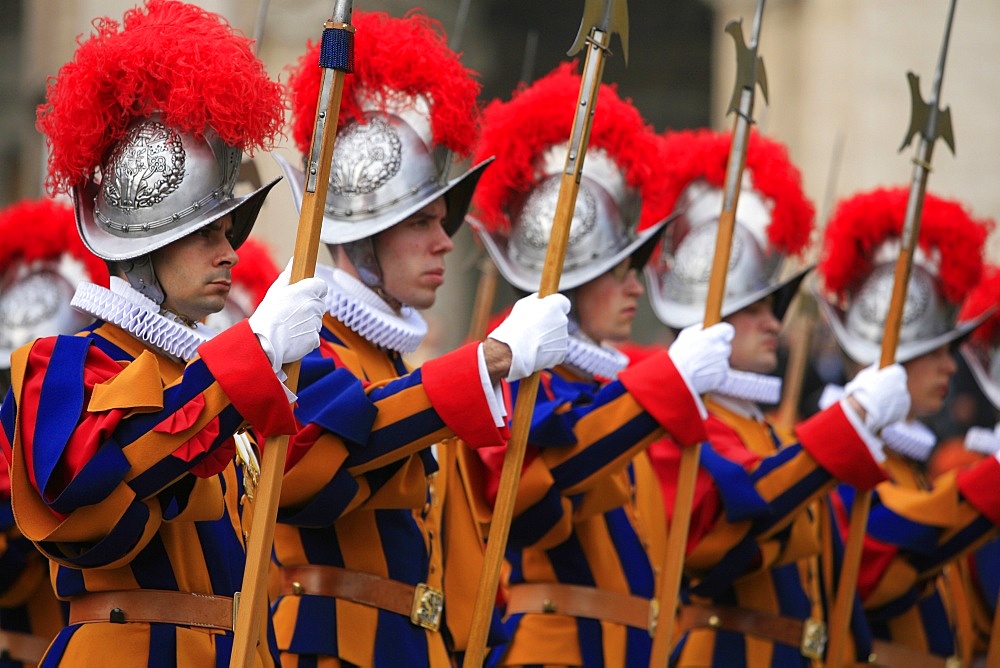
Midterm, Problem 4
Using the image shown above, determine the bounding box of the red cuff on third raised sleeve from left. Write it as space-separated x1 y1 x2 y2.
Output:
618 350 708 447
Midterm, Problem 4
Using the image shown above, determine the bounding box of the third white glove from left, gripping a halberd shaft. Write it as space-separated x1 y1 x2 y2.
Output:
667 322 736 395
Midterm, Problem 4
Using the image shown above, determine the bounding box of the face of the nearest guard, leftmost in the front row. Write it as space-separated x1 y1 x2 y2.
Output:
152 215 239 320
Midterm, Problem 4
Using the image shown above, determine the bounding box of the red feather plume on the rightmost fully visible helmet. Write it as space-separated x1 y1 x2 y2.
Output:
818 188 993 304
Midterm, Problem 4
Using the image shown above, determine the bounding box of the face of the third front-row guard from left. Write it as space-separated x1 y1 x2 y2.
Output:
574 258 645 342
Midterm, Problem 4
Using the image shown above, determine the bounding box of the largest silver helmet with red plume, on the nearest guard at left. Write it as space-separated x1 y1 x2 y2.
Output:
37 0 283 303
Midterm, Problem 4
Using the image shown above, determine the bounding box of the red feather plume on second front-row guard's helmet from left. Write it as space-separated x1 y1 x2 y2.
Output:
288 10 480 157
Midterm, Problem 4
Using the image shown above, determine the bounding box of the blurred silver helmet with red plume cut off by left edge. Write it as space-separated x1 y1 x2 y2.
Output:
0 199 108 369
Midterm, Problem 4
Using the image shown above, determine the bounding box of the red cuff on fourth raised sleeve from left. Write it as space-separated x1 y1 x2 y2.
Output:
795 403 888 491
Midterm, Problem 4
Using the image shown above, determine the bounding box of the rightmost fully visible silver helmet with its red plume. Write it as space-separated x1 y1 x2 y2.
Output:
818 188 993 366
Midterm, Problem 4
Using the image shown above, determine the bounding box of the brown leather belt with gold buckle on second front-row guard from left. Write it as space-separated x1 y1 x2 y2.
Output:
281 564 444 631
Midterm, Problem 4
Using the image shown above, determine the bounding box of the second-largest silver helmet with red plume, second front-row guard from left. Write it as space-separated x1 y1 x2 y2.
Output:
275 11 486 260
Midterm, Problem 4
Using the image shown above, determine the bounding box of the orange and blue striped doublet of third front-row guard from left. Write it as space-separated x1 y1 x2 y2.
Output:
484 351 706 666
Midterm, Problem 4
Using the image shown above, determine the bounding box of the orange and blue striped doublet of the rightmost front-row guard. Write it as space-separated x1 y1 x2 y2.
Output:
838 452 1000 658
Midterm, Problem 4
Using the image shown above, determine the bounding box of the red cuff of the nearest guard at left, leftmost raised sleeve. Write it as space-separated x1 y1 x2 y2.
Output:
198 320 296 438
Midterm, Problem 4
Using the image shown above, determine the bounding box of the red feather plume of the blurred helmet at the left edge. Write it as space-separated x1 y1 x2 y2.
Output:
0 199 109 287
